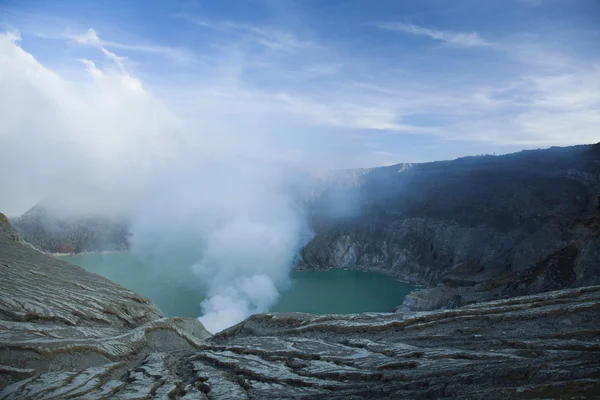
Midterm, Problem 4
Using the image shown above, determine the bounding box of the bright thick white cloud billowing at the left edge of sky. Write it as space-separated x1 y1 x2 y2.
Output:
0 30 177 217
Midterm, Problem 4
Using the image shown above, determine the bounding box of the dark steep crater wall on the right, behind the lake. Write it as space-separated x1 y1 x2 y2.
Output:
298 144 600 310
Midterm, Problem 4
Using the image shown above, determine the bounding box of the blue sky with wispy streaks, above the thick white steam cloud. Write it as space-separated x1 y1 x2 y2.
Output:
2 0 600 165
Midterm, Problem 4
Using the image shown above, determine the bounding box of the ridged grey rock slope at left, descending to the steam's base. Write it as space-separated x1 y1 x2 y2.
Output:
0 214 210 399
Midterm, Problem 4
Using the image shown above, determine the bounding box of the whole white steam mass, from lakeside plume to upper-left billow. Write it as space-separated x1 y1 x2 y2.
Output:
0 29 316 332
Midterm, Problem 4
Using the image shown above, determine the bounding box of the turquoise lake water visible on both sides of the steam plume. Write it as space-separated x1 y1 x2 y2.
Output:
59 253 411 317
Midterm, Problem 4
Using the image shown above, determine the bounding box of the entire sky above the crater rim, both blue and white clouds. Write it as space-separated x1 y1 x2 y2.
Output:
0 0 600 215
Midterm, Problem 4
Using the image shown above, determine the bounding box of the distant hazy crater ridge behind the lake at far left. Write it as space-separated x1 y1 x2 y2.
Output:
11 204 130 253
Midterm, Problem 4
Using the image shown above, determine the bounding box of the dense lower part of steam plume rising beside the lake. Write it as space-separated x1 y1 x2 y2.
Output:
194 203 310 332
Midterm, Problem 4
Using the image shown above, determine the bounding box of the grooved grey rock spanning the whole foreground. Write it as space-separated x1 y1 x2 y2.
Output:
0 214 600 400
